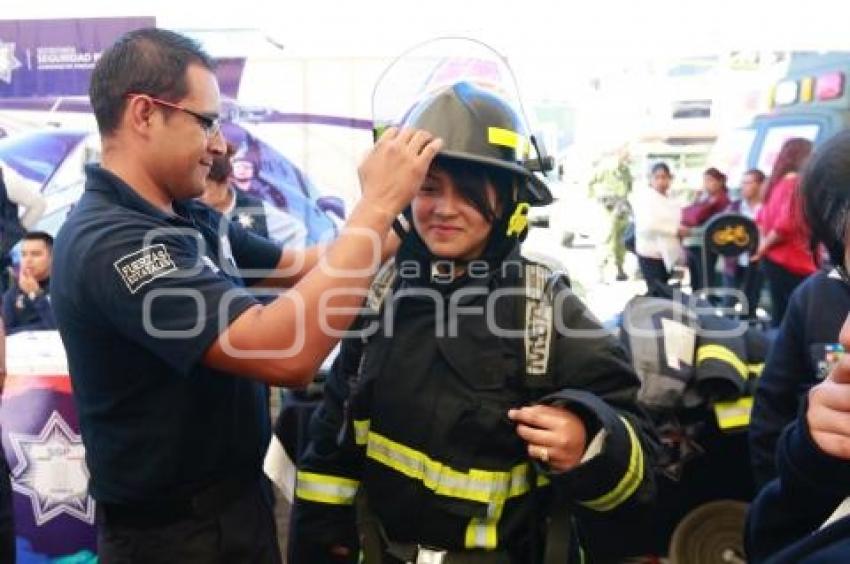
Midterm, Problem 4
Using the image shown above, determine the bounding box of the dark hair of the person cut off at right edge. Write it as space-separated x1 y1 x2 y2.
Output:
800 131 850 271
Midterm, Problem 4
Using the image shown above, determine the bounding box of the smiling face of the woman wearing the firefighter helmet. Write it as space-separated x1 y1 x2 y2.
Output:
411 166 498 261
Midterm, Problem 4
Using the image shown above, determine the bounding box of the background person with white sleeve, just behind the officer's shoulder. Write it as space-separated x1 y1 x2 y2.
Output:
201 143 307 249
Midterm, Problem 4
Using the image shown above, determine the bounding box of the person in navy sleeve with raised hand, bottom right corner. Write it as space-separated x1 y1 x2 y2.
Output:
745 316 850 564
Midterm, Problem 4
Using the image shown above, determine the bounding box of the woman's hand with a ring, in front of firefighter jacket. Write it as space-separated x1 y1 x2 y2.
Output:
508 405 587 472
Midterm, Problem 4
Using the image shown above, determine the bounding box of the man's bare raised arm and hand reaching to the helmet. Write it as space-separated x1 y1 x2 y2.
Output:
204 128 442 386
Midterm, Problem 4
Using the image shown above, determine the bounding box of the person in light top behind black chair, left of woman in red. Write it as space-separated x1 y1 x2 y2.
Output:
723 168 765 319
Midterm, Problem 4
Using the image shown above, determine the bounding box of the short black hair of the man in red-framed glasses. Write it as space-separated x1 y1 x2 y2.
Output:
89 28 215 136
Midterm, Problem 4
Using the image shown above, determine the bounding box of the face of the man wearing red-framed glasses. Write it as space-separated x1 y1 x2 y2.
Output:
148 64 226 200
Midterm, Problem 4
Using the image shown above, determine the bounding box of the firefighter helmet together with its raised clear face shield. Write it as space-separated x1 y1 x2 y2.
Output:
372 38 552 205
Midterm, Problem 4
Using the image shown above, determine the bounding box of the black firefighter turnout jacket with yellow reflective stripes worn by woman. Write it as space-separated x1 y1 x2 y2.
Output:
292 250 655 562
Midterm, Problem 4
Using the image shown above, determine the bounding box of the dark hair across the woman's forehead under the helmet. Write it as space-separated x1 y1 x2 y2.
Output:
435 156 517 223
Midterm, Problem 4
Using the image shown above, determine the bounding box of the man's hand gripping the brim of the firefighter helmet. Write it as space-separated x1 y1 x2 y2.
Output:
358 127 443 221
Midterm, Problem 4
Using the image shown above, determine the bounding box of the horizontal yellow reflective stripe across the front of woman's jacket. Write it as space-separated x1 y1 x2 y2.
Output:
366 431 529 504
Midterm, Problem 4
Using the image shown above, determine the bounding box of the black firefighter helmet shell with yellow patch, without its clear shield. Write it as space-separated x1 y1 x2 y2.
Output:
401 81 552 206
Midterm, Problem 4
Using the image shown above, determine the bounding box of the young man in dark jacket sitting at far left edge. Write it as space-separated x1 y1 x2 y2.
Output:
3 231 56 335
